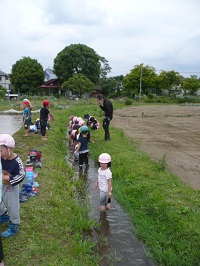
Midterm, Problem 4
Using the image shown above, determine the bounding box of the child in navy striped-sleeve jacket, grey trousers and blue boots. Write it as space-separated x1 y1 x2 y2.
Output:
0 134 25 237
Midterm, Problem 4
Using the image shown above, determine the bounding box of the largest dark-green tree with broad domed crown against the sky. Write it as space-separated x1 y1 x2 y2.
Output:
54 44 110 84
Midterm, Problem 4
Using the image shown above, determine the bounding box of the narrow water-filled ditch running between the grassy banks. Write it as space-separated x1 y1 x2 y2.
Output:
67 146 157 266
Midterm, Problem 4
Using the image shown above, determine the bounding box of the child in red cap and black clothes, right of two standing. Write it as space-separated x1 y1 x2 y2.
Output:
40 100 54 140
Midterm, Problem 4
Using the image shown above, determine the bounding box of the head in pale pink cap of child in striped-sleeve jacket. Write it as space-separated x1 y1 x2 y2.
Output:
0 134 15 160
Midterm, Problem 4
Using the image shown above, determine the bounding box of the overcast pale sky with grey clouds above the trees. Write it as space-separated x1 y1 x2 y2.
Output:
0 0 200 76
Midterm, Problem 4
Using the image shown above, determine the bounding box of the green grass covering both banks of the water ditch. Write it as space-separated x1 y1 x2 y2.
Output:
1 96 200 266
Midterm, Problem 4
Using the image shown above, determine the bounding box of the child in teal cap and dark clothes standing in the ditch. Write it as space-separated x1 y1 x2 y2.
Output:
76 126 94 171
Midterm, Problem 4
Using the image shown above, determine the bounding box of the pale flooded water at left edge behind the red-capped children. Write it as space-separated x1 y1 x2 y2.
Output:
0 114 22 135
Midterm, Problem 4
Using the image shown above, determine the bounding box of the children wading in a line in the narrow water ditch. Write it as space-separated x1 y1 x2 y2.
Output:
68 115 112 212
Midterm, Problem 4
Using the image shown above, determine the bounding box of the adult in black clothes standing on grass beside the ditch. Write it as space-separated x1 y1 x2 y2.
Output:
97 94 113 141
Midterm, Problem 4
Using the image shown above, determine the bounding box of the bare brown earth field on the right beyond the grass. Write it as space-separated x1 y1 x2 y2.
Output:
111 105 200 190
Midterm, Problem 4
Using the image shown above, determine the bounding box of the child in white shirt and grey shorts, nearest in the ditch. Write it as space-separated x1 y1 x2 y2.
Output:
95 153 112 212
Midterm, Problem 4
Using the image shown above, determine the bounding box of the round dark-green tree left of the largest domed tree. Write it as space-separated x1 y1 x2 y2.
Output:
10 57 44 93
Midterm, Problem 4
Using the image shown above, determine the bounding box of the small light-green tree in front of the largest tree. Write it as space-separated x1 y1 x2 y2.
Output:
62 74 94 97
